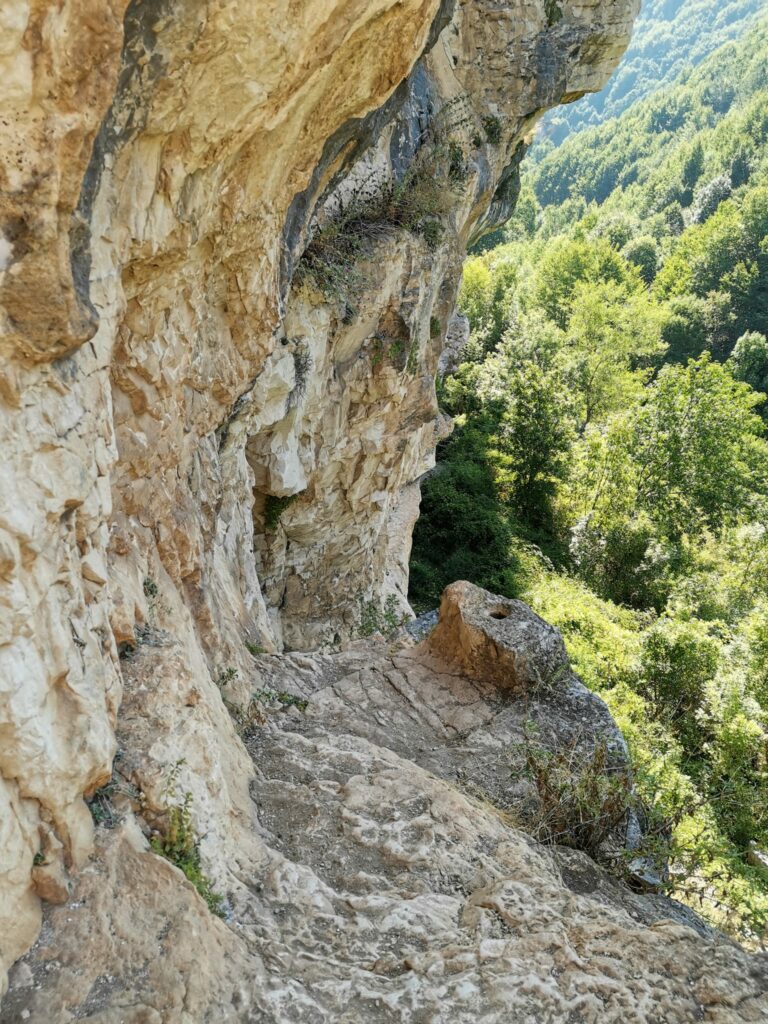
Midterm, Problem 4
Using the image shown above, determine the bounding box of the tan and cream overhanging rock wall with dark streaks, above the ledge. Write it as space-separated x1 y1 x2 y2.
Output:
0 0 637 995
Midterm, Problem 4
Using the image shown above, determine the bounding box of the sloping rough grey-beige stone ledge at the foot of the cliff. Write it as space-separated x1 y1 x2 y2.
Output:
6 585 768 1024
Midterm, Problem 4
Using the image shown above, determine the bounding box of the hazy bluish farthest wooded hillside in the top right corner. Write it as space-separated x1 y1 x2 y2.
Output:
536 0 766 148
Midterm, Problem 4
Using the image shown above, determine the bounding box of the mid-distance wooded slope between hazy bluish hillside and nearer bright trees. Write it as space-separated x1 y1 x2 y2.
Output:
526 22 768 220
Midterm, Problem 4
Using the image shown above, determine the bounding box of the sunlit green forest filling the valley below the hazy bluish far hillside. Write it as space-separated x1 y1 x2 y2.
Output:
412 19 768 941
